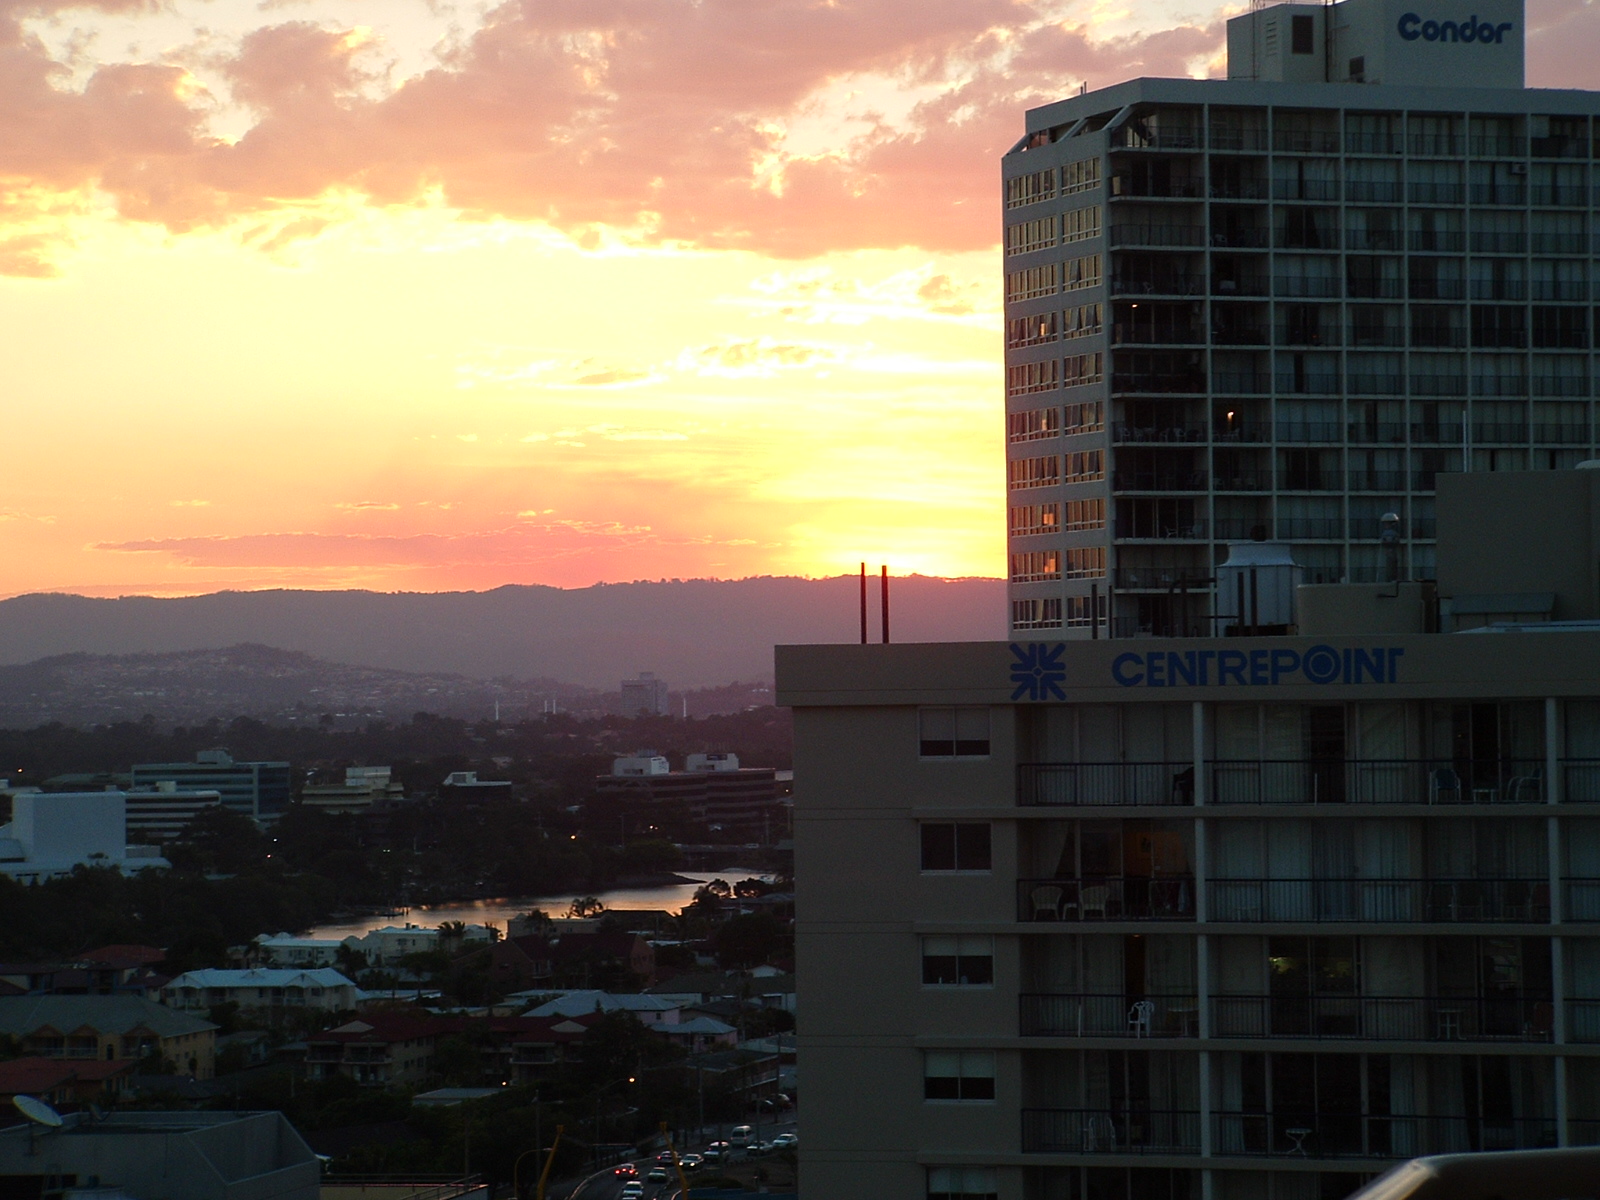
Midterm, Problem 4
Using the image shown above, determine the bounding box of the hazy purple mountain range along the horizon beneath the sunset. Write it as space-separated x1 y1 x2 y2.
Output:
0 576 1005 691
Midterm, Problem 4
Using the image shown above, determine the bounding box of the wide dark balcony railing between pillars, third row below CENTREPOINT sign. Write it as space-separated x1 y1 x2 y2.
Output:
1211 995 1548 1042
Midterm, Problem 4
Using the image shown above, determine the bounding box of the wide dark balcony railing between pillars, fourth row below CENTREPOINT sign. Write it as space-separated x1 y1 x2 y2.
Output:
1213 1109 1557 1158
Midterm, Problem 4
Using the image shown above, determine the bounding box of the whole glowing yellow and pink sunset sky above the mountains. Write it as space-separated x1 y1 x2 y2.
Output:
0 0 1600 595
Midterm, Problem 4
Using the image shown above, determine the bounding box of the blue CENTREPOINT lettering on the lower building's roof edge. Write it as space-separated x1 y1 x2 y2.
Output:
1110 646 1405 688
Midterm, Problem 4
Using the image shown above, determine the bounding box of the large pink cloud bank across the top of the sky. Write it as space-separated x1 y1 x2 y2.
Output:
0 0 1221 266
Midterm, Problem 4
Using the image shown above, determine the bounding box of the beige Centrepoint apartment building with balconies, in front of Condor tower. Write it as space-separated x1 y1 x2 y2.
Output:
778 629 1600 1200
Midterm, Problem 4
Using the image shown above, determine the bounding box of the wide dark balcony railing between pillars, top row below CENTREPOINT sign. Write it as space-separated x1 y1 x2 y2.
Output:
1206 761 1548 805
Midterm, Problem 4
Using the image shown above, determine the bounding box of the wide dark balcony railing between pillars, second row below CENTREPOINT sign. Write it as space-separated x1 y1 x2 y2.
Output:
1210 878 1550 925
